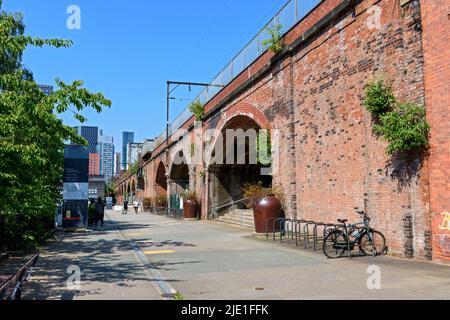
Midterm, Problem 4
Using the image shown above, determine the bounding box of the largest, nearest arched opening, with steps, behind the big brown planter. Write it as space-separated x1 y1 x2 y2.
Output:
208 115 272 215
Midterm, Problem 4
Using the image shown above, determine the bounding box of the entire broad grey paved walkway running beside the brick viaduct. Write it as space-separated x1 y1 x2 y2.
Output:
25 212 450 300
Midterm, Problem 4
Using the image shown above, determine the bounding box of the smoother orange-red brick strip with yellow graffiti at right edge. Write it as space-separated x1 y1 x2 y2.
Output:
420 0 450 262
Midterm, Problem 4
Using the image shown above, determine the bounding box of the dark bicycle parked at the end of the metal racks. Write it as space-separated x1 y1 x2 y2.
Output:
323 211 386 259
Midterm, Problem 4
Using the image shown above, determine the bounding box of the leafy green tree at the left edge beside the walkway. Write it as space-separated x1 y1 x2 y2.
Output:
0 0 111 249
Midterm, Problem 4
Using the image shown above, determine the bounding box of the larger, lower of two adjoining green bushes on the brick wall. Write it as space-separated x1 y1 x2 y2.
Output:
374 103 430 155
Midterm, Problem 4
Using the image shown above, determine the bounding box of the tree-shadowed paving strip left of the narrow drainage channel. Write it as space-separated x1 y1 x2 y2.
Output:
23 215 160 300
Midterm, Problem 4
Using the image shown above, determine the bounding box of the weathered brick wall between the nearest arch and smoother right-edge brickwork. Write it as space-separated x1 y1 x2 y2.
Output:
214 0 431 259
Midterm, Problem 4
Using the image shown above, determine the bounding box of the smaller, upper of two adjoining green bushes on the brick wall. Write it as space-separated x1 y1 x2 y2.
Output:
364 79 396 116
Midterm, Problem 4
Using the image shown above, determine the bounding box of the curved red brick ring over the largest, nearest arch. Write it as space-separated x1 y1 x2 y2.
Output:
207 102 272 163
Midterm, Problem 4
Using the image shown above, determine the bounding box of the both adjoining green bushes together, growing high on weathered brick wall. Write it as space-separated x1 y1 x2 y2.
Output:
364 80 430 155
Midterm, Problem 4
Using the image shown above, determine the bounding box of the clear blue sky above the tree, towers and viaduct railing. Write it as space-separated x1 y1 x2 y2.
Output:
3 0 287 151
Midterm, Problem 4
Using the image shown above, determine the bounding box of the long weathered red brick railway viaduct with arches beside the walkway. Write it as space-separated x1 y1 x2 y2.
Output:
115 0 450 263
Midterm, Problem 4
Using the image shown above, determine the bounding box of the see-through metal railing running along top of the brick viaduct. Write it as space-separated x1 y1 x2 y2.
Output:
154 0 323 149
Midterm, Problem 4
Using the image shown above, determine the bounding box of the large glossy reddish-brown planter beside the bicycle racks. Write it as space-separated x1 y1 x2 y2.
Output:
253 195 281 233
